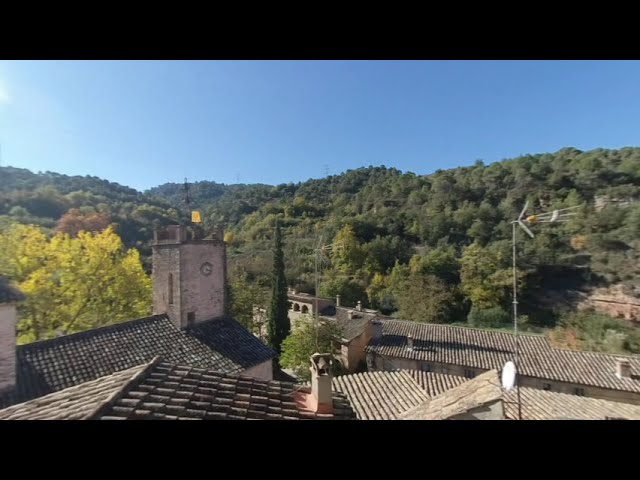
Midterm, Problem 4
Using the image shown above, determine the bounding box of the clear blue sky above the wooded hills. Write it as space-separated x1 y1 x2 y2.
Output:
0 61 640 189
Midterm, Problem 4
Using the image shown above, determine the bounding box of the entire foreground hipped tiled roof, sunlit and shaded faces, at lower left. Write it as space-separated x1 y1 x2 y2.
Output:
0 358 355 420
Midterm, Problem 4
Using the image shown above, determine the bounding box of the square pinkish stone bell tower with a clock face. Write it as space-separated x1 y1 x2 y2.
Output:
151 225 227 328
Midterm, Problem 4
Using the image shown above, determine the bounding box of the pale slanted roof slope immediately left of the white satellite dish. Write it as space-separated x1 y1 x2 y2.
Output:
399 370 502 420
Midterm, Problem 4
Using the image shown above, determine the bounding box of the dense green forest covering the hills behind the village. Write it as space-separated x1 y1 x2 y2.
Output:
0 148 640 351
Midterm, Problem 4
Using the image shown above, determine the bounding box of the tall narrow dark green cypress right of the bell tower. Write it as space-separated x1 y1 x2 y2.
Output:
267 222 291 353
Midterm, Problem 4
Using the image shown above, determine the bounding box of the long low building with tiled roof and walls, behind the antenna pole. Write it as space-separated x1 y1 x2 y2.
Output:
365 319 640 404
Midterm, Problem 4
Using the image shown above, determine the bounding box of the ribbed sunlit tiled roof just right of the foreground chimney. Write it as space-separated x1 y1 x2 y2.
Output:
333 370 429 420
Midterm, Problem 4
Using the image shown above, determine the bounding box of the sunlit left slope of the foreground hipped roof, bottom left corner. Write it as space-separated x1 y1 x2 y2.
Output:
0 364 148 420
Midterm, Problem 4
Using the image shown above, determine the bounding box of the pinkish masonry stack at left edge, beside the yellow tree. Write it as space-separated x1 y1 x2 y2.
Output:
0 276 24 393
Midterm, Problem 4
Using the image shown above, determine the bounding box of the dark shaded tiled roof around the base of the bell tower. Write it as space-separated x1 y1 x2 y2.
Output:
0 315 275 406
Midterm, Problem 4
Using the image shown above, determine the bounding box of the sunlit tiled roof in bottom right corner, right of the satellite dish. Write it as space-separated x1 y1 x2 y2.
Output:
504 387 640 420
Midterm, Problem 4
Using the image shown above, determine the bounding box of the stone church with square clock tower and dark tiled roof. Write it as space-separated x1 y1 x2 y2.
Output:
0 225 276 406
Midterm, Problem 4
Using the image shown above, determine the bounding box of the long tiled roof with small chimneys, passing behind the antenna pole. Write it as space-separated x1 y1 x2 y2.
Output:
366 320 640 393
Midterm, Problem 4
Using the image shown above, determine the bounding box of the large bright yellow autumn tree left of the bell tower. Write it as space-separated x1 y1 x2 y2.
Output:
0 225 151 343
